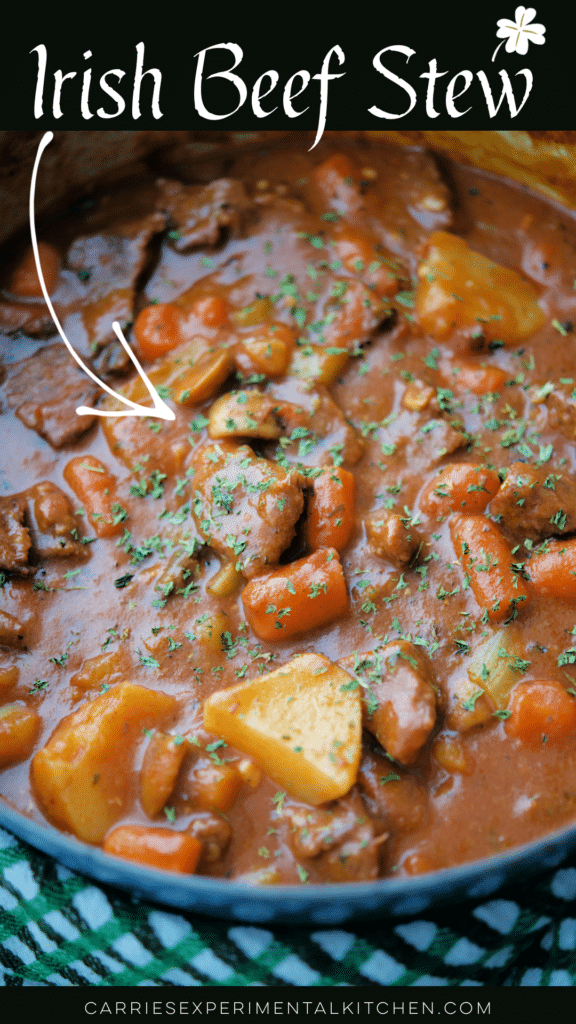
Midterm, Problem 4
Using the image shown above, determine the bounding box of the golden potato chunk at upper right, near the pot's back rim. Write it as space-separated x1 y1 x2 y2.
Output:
416 231 544 345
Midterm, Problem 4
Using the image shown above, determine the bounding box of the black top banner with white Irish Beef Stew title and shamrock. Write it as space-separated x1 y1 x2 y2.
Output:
0 0 574 134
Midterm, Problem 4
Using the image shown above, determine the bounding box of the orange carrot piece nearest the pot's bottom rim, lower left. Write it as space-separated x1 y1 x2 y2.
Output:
104 825 202 874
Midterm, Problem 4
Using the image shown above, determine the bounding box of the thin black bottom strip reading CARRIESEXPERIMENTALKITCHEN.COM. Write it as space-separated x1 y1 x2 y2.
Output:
1 986 576 1024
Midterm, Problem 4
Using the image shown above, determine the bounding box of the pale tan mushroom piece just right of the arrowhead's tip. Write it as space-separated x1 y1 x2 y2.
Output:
208 391 284 440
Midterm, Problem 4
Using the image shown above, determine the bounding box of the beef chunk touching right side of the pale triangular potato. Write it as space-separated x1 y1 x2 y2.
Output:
338 641 437 765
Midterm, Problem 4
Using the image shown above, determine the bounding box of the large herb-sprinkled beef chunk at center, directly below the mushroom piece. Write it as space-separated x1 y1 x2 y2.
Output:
193 441 303 579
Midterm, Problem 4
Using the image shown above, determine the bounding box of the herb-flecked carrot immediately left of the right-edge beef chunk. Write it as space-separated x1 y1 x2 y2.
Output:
418 462 500 517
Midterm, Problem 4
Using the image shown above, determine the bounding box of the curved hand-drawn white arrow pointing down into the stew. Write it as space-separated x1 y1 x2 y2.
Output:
30 131 176 420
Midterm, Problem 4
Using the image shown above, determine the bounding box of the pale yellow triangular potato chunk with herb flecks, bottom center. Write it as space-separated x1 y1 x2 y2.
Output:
204 654 362 806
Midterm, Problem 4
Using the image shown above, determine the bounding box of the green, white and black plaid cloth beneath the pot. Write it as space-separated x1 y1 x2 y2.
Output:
0 829 576 987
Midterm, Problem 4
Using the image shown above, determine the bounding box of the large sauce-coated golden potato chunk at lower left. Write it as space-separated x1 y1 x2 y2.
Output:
32 683 175 843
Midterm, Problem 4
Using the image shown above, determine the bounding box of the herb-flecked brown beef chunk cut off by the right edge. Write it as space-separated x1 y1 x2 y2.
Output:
490 462 576 541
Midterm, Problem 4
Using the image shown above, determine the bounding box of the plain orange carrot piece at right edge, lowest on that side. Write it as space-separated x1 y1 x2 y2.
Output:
505 679 576 743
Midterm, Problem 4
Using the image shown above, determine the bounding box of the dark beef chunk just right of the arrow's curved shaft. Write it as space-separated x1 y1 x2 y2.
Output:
65 212 165 356
